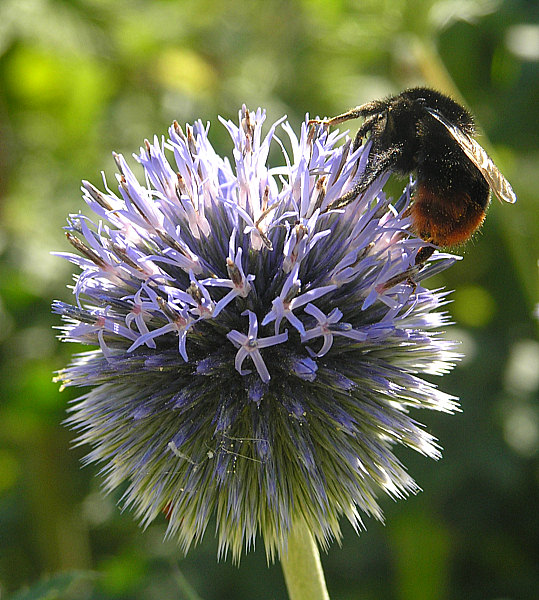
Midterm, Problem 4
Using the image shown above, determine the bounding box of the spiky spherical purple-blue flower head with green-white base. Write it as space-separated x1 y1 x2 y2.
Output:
54 107 456 559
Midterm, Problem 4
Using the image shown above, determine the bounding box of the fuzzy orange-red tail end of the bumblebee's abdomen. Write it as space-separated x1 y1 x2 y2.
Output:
410 183 488 246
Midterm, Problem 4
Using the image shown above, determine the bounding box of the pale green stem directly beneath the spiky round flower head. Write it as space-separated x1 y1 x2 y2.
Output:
281 522 329 600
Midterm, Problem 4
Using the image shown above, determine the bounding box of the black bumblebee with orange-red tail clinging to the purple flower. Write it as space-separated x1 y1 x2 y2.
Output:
316 87 516 264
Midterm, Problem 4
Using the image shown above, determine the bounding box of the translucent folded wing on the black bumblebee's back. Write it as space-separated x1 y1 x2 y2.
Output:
425 108 517 204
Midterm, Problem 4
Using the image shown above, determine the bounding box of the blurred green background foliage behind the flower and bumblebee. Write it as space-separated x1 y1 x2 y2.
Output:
0 0 539 600
